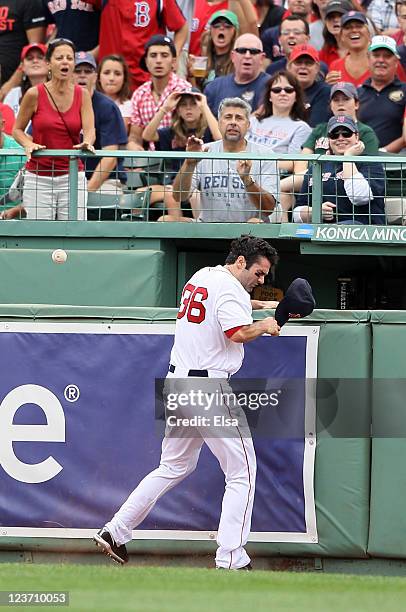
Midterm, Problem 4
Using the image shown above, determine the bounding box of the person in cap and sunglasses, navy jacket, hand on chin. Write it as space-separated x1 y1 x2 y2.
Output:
293 115 385 225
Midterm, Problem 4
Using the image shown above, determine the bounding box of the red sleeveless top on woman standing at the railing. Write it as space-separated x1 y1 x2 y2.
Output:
25 83 83 176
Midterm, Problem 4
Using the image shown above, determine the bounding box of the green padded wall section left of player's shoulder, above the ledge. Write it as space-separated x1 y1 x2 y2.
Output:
0 249 176 306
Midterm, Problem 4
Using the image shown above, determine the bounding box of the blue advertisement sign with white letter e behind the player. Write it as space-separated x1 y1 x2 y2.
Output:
0 323 319 543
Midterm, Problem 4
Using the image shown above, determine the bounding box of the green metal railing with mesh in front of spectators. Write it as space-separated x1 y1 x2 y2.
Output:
0 149 406 225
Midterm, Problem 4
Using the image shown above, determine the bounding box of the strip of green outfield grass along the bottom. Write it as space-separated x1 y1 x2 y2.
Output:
0 563 406 612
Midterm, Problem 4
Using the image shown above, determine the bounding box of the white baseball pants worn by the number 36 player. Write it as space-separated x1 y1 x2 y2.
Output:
106 379 256 569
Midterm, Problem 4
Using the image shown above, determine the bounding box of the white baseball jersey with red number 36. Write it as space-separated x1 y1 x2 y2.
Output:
171 266 252 374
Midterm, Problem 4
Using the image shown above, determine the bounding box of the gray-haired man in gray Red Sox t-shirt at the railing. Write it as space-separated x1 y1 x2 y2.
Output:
173 98 279 223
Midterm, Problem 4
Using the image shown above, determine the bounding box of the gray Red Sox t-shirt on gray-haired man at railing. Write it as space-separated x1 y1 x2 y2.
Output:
192 140 279 223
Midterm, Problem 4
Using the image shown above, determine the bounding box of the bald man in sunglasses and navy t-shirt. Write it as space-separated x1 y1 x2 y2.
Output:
204 34 269 116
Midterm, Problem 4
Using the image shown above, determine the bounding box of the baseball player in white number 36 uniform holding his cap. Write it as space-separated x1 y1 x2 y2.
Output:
94 236 280 570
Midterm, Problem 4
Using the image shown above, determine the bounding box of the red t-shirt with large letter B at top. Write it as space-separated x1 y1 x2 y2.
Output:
86 0 186 89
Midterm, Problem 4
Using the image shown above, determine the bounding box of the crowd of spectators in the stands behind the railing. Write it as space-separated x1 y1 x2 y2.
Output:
0 0 406 223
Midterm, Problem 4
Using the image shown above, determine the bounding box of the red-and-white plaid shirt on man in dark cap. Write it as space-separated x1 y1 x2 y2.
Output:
131 72 192 127
